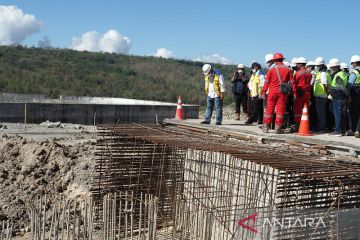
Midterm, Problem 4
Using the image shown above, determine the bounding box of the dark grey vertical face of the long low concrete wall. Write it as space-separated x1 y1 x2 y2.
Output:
0 103 199 125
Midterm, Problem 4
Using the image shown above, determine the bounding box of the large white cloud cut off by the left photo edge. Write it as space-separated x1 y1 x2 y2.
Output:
0 5 43 45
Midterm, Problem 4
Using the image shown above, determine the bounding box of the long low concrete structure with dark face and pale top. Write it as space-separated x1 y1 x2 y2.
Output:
0 94 199 125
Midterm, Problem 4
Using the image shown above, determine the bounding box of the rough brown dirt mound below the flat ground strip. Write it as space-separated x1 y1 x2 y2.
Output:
0 134 95 234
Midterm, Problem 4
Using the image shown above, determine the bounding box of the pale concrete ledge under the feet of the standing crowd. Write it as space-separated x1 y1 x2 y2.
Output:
164 119 360 157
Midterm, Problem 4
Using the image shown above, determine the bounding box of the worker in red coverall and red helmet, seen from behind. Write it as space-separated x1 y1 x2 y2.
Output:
262 53 293 134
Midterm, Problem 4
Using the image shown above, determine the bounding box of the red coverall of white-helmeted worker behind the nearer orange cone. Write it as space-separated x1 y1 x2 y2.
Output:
293 67 312 124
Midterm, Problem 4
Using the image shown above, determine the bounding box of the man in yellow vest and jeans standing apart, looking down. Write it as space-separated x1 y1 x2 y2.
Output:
201 64 225 125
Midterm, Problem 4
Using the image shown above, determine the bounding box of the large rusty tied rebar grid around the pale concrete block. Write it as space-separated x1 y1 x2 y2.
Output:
92 124 360 239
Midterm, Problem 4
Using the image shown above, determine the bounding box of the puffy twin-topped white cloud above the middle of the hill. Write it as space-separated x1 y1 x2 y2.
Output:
72 29 131 53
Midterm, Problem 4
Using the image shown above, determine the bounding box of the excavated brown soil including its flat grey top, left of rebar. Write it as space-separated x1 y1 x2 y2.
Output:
0 124 96 239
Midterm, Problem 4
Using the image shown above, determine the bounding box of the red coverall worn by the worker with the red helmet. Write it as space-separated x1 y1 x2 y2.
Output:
263 62 293 127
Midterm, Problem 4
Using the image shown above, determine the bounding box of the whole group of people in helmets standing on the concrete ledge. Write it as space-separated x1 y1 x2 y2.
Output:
202 53 360 138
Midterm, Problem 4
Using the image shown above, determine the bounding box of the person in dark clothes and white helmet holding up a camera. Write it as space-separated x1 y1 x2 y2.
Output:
231 64 249 120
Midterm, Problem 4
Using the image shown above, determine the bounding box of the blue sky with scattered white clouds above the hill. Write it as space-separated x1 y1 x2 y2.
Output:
0 0 360 64
